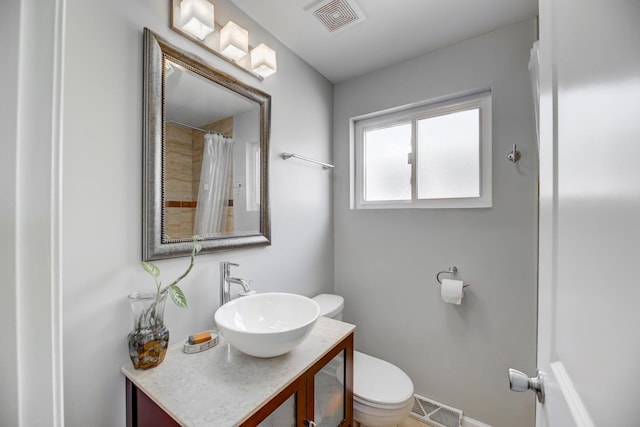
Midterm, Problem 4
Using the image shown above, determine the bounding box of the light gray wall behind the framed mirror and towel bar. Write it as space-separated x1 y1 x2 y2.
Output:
56 0 333 427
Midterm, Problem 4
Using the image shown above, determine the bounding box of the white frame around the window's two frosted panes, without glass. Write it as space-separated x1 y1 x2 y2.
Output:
350 91 492 209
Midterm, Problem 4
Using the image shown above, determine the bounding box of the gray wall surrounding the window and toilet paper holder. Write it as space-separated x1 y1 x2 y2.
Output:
334 20 537 427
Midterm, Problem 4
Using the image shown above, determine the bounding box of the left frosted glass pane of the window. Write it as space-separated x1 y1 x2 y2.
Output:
364 123 411 201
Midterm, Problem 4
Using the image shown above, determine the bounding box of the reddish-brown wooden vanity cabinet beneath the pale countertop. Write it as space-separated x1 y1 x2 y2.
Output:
127 332 353 427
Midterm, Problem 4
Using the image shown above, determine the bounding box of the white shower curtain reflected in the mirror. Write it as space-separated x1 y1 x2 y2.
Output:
194 133 233 238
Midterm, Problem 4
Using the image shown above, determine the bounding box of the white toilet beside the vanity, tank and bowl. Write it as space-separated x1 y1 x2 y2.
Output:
313 294 413 427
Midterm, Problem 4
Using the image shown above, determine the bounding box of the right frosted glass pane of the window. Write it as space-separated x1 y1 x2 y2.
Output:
417 108 480 199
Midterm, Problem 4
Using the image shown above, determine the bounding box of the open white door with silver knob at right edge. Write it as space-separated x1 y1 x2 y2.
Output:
516 0 640 427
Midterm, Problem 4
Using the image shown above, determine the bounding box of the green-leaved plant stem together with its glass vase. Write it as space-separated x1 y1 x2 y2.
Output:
127 236 202 369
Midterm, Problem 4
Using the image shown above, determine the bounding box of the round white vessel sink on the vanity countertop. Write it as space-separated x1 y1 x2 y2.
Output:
215 292 320 357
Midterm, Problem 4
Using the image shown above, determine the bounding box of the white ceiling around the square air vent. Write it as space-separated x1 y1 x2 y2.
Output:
231 0 538 83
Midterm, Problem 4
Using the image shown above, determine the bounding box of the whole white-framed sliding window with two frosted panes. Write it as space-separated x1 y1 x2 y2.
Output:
352 92 491 209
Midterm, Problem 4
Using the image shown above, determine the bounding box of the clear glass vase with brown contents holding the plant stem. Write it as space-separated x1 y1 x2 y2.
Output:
127 292 169 369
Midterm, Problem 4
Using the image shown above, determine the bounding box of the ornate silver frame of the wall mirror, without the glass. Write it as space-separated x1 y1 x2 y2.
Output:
142 28 271 261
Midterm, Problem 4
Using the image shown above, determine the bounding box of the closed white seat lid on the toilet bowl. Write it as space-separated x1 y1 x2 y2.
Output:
338 351 413 408
